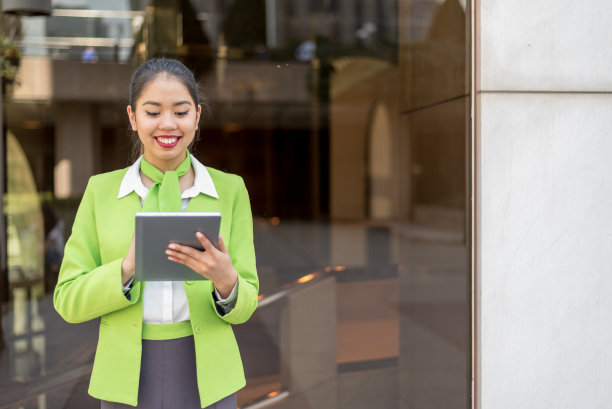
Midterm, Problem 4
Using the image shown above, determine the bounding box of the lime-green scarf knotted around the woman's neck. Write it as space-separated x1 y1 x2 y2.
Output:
140 151 191 212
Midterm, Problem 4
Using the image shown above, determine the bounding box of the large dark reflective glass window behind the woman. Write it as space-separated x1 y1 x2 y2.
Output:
0 0 472 409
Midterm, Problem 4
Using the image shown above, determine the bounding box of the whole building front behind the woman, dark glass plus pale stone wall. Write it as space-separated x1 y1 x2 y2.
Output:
0 0 612 409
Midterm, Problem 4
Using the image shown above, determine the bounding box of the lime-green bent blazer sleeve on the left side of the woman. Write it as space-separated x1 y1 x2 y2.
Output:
53 177 140 323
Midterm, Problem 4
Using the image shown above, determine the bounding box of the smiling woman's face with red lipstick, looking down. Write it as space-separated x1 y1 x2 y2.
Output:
127 75 201 171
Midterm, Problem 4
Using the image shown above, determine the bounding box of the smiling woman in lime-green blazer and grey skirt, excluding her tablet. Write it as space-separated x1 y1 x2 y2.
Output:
54 59 259 409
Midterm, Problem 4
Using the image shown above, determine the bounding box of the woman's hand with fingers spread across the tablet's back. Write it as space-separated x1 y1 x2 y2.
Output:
166 232 238 298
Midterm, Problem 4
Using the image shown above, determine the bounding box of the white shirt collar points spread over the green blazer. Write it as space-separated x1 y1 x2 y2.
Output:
117 154 219 199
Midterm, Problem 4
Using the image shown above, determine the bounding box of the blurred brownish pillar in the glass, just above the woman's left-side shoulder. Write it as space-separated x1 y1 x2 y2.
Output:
54 103 96 198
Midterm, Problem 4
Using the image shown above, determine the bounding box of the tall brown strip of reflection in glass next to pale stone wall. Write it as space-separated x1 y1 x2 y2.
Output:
399 0 471 408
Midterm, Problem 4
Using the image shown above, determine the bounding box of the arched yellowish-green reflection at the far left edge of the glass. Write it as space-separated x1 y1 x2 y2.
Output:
2 132 45 403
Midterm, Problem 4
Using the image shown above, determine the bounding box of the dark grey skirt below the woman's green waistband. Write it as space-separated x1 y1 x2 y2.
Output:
100 336 237 409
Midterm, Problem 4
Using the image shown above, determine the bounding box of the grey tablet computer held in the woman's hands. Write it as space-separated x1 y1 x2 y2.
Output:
134 212 221 281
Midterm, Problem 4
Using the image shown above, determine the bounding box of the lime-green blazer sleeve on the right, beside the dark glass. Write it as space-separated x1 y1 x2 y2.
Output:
210 177 259 324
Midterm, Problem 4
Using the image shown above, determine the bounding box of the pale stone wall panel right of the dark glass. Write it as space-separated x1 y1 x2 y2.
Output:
473 0 612 409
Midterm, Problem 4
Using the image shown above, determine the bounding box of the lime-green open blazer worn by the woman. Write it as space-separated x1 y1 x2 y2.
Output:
53 168 259 407
